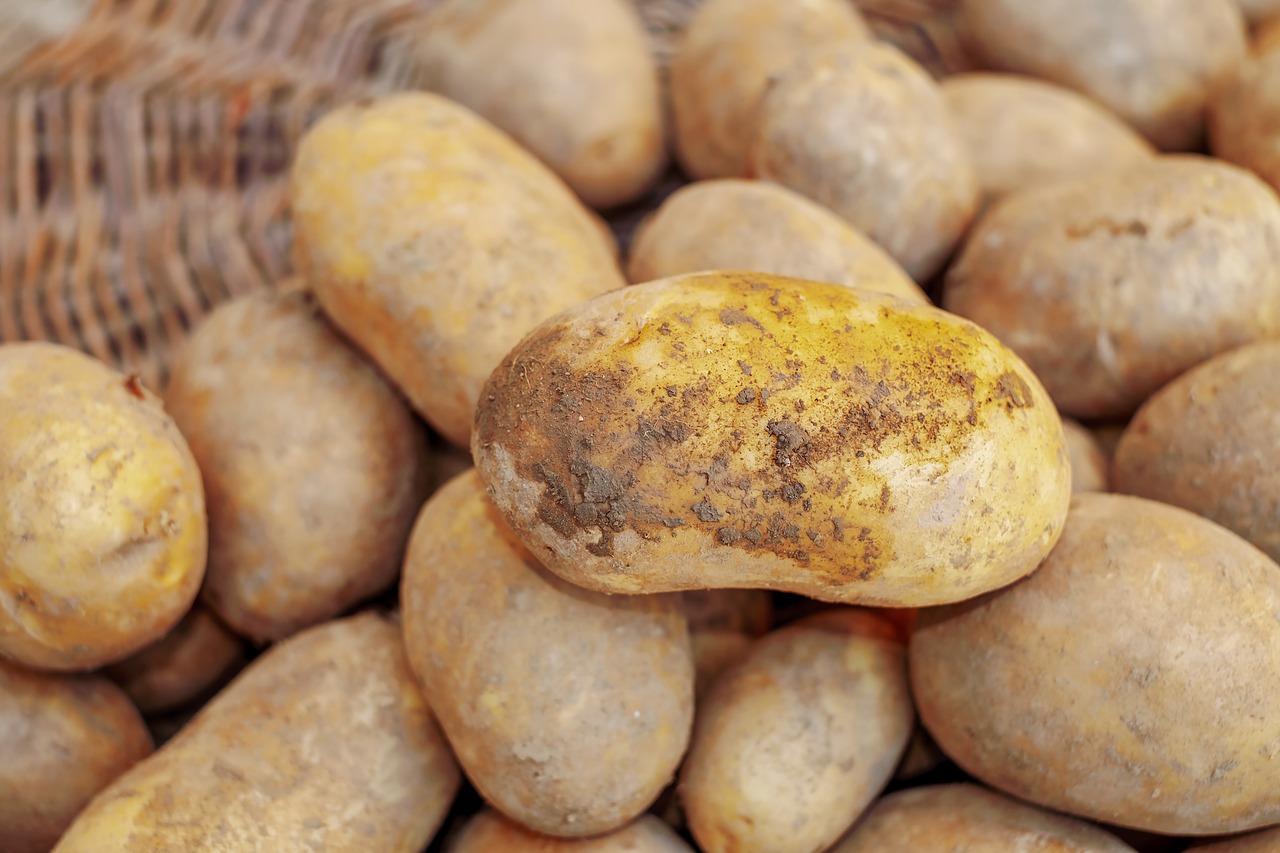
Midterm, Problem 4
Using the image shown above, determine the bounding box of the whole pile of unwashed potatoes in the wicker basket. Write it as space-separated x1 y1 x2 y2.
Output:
0 0 1280 853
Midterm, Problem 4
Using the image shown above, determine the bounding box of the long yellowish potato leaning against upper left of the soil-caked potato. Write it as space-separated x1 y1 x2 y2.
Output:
293 92 626 446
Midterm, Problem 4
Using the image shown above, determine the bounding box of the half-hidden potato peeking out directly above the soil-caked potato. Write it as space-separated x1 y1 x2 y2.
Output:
627 179 928 302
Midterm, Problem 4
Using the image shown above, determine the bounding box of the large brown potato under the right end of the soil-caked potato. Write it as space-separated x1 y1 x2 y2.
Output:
910 493 1280 835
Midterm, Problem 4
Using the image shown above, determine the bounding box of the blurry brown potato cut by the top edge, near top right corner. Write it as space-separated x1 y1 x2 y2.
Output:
956 0 1245 150
